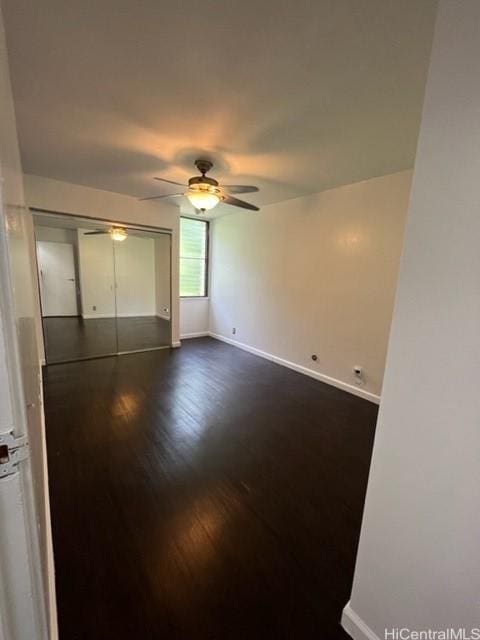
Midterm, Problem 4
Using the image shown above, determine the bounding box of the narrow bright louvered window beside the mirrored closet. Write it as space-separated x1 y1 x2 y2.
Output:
180 218 208 298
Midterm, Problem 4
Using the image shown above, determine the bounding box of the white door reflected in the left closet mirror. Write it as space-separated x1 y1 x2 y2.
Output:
37 241 78 316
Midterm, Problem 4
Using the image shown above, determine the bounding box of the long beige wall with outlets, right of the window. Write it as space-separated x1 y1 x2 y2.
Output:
210 171 411 399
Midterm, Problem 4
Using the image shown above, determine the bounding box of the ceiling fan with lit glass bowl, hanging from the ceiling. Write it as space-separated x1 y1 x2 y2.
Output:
140 159 259 213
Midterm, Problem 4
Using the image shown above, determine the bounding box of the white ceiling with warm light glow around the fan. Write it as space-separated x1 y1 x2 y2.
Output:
3 0 437 215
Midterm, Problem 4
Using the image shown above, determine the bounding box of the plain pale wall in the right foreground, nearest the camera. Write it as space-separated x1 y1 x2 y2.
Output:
344 0 480 639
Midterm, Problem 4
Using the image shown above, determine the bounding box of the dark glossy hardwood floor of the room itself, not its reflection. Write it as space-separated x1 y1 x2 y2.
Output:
45 338 377 640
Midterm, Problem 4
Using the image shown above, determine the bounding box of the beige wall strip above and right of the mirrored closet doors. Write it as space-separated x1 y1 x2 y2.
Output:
24 175 179 344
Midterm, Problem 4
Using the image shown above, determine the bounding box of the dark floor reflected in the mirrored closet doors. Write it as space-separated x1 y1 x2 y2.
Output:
43 316 170 363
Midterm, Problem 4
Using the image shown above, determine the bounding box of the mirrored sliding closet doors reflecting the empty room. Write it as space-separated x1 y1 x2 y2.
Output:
33 212 172 364
